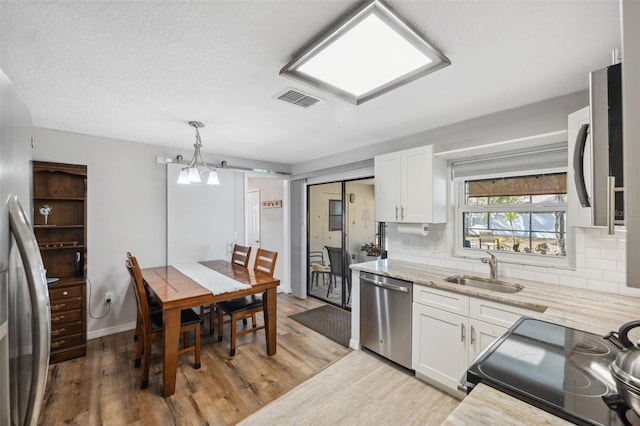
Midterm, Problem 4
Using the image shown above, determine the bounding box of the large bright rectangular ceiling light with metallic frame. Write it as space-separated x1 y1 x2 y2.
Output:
280 0 451 105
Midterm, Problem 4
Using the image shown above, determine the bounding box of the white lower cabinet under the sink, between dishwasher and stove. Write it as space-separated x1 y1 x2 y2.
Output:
412 285 538 395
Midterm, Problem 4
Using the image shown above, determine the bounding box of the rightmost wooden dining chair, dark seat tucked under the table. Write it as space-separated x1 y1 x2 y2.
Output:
217 248 278 356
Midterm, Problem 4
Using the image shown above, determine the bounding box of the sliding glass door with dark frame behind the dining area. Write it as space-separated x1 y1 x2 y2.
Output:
307 178 377 309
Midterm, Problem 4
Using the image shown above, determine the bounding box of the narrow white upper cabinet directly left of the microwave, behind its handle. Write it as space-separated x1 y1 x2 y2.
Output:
567 107 593 226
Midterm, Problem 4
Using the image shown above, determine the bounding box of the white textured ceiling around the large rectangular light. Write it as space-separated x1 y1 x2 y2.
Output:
0 0 620 164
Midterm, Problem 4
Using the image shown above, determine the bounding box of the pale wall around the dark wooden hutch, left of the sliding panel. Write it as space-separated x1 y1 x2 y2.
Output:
33 129 167 338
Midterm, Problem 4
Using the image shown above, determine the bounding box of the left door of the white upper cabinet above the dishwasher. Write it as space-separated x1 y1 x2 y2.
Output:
374 152 400 222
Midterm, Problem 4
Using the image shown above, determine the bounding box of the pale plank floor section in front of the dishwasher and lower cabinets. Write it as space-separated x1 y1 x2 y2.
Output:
240 351 459 426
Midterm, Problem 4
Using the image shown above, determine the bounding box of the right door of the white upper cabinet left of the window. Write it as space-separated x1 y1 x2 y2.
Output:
399 145 433 223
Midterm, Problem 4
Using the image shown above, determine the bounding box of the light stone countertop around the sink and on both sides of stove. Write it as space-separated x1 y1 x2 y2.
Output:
351 259 640 425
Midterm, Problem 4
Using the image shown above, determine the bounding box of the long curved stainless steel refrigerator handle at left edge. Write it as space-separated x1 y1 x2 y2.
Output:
9 195 51 425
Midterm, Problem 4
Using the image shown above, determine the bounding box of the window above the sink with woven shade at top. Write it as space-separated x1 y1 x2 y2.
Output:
457 173 567 257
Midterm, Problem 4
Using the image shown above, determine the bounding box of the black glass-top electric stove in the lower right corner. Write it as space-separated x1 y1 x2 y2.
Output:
467 317 640 426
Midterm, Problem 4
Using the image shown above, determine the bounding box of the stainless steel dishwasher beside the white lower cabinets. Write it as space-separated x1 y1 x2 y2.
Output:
360 272 413 368
